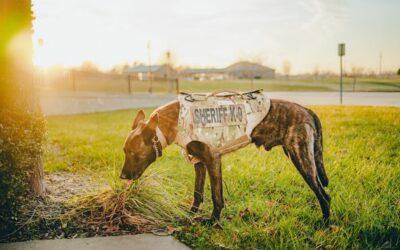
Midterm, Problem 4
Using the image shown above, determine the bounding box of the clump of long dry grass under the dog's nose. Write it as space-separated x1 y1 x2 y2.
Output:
63 171 189 233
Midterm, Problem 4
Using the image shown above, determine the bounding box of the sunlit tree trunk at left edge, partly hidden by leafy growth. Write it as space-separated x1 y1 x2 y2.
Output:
0 0 46 196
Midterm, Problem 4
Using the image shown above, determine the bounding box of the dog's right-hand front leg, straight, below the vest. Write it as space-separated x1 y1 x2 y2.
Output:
206 155 224 221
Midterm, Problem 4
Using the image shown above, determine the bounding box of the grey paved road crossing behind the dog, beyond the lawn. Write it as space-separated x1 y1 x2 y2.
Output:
40 92 400 115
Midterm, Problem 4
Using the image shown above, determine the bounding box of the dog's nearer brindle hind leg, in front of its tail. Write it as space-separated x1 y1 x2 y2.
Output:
285 124 330 219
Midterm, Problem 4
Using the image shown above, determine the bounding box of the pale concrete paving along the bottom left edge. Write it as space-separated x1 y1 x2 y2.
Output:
0 234 189 250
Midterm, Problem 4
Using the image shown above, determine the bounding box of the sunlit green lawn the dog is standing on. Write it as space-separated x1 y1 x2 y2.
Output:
45 106 400 249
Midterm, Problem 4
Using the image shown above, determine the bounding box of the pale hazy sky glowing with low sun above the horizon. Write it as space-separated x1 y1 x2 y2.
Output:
33 0 400 74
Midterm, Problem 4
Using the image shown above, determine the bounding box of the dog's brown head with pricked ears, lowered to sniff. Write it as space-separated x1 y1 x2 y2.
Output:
120 110 158 180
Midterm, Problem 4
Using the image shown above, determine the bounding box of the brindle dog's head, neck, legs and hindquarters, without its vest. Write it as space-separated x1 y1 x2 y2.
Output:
120 100 331 220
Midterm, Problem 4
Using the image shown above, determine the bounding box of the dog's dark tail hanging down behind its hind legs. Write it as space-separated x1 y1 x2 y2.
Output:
308 110 329 187
